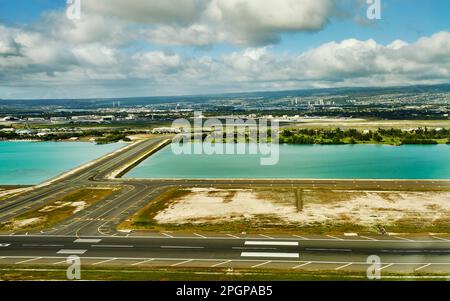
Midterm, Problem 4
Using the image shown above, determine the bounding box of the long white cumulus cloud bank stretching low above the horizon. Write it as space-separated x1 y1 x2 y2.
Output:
0 12 450 97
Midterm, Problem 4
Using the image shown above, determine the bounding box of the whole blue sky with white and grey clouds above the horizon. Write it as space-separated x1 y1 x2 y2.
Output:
0 0 450 99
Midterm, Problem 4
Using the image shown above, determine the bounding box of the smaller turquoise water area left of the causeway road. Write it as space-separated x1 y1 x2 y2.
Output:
0 142 123 185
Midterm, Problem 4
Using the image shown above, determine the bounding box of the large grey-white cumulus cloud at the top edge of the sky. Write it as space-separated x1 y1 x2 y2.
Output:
79 0 334 46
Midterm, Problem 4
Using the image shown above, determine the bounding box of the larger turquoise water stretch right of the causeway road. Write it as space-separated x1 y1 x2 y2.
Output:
126 145 450 179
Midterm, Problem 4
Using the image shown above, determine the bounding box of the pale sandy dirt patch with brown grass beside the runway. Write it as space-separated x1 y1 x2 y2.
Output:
125 188 450 233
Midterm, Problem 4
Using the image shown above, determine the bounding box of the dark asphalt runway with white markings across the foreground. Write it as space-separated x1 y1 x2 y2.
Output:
0 236 450 275
